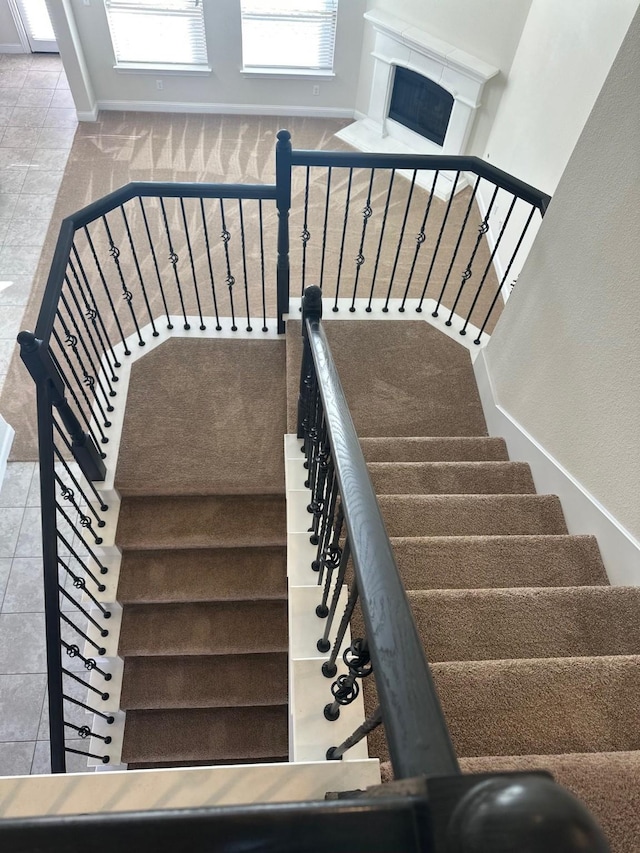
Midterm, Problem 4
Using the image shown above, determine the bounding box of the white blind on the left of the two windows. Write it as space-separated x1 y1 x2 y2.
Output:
105 0 207 65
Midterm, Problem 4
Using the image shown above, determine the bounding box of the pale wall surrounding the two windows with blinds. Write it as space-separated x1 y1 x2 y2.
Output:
65 0 365 116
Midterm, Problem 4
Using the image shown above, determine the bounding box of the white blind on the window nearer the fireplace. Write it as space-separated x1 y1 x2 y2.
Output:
241 0 338 71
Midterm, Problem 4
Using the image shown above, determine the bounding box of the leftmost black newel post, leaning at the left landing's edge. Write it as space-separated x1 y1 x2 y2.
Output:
18 332 106 481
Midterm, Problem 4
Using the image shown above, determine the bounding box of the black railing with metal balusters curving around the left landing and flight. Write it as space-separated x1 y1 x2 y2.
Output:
18 176 288 773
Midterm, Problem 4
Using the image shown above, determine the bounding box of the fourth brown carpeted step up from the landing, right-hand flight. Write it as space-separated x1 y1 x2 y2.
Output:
391 535 608 589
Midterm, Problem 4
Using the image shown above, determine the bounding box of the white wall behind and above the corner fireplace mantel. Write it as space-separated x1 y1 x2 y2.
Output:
356 0 532 156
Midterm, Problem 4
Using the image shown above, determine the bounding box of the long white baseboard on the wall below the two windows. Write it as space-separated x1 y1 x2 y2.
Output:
97 101 353 119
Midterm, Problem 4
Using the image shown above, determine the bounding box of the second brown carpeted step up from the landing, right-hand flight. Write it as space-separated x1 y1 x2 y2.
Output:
367 462 535 495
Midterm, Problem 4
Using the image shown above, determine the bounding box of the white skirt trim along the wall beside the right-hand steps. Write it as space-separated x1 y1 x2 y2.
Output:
474 351 640 586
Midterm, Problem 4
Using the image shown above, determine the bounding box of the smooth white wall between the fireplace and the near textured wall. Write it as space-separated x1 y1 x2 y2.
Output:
484 0 638 195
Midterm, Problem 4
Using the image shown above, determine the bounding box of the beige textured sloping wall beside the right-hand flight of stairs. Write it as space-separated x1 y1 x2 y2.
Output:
486 3 640 537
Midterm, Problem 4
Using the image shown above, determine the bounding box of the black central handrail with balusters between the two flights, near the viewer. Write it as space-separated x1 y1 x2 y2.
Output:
298 286 608 853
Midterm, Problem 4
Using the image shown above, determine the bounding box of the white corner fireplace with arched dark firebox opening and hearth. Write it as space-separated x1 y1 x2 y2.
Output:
337 10 499 198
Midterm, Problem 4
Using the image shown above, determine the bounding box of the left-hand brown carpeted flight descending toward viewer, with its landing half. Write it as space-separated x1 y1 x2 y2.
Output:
116 340 288 769
